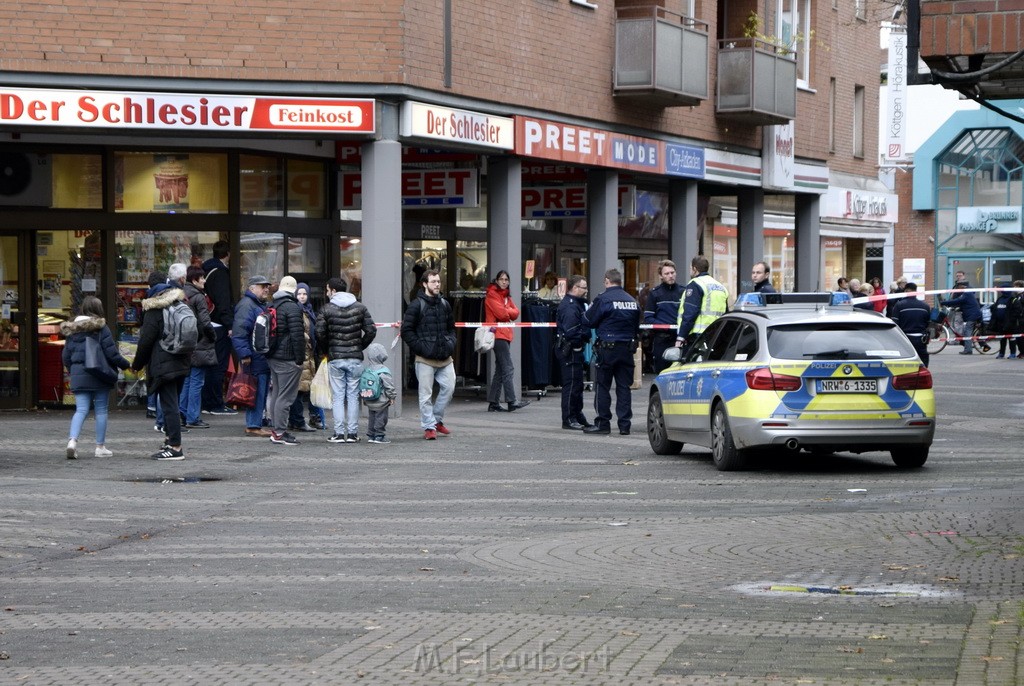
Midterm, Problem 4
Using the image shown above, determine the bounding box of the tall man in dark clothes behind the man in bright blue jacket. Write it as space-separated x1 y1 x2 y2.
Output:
203 241 238 415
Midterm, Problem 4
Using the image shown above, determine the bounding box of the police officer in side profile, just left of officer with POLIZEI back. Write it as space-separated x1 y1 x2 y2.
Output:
555 274 591 431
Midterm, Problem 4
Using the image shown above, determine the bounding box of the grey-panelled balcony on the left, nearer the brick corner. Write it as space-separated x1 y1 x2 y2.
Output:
612 7 709 108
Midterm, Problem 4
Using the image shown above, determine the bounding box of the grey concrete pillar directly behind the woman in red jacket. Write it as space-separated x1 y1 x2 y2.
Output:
487 156 522 401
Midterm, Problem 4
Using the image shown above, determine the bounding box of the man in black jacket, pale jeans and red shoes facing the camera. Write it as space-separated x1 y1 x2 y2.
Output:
401 269 455 440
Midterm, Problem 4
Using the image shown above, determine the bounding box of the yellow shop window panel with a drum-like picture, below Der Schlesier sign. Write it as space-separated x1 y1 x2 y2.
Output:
114 153 227 214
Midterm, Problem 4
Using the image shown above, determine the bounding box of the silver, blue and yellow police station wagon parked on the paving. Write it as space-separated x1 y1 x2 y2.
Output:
647 293 935 471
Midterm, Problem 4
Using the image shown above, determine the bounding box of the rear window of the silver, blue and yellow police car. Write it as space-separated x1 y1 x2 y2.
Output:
768 323 915 359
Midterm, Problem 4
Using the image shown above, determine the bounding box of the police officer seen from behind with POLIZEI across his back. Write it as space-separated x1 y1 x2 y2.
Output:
583 269 642 436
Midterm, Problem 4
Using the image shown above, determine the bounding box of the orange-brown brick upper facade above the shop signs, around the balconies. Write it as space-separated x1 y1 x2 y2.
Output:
0 0 882 176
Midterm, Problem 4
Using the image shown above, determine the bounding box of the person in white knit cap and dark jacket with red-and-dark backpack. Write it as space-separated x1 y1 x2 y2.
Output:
267 276 306 445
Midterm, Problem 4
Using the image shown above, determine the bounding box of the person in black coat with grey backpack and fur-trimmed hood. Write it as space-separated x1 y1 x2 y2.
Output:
131 276 199 461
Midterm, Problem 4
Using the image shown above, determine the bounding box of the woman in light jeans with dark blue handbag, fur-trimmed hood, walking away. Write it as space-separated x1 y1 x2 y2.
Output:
60 295 131 460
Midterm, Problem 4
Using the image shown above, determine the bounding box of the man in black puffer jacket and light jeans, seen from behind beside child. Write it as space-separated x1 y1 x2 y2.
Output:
316 276 377 443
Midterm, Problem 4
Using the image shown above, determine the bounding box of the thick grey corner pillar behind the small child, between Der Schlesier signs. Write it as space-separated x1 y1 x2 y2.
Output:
360 127 404 417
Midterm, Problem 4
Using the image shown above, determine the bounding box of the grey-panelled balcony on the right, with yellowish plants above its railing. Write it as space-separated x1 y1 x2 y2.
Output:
715 38 797 126
